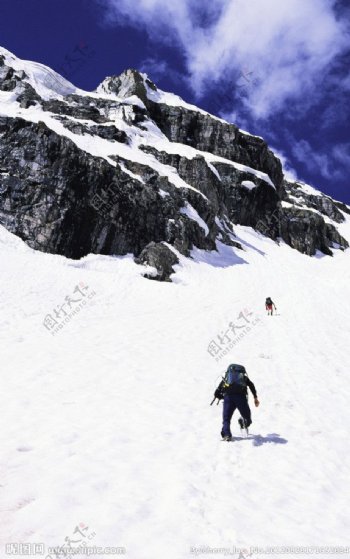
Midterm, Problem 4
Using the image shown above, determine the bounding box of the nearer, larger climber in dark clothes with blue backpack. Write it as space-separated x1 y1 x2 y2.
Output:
212 364 260 441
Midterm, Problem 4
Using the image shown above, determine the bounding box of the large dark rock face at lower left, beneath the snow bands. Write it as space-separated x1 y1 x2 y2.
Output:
0 117 218 258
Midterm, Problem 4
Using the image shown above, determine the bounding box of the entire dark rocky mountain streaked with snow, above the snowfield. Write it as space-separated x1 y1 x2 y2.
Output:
0 49 349 280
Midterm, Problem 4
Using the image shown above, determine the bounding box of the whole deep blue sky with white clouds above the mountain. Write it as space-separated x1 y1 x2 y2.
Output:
0 0 350 203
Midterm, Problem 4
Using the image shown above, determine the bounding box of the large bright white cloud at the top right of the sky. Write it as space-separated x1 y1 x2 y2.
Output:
95 0 349 118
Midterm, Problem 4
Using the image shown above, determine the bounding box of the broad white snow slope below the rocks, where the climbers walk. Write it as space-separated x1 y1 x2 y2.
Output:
0 207 350 559
